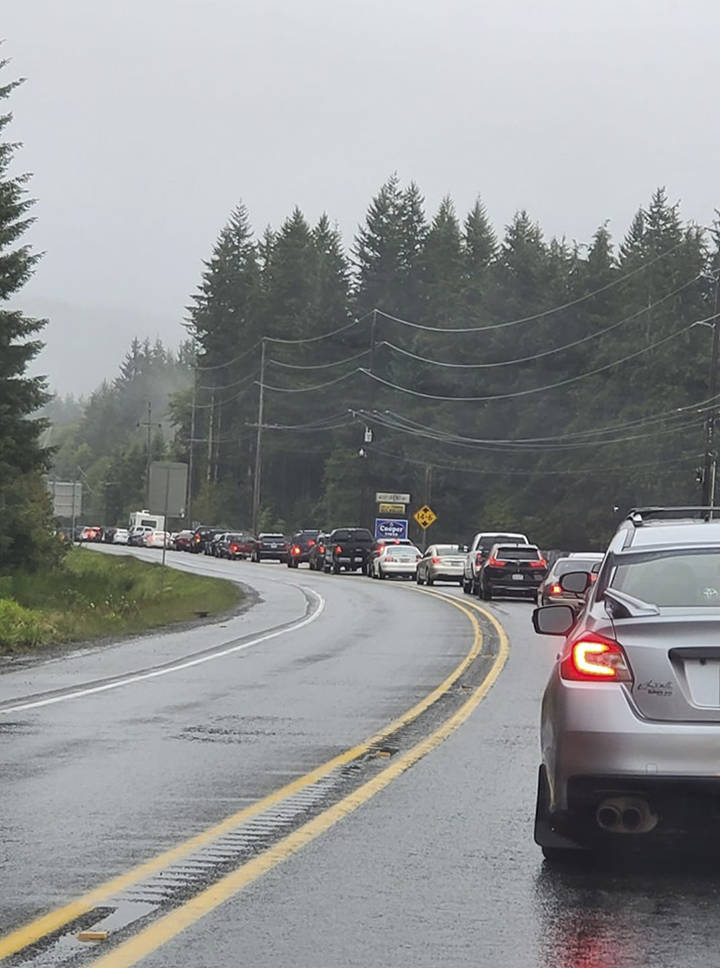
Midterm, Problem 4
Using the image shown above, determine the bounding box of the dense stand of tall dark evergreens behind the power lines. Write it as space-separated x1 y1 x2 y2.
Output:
179 176 720 546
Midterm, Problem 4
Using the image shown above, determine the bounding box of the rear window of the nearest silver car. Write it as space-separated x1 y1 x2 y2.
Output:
610 551 720 608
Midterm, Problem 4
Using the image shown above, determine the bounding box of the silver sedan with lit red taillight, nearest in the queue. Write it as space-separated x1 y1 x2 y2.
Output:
533 508 720 859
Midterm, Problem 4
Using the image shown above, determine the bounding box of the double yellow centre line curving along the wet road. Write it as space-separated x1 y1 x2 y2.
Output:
0 591 509 968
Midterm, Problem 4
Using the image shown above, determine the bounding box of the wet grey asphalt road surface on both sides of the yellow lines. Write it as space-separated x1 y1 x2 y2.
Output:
0 556 720 968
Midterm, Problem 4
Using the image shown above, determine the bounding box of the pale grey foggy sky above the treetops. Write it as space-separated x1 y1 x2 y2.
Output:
5 0 720 393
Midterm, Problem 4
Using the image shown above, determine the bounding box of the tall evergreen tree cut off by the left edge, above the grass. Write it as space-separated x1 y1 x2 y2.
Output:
0 68 57 569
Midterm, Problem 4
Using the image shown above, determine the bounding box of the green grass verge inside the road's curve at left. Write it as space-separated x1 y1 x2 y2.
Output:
0 549 243 656
